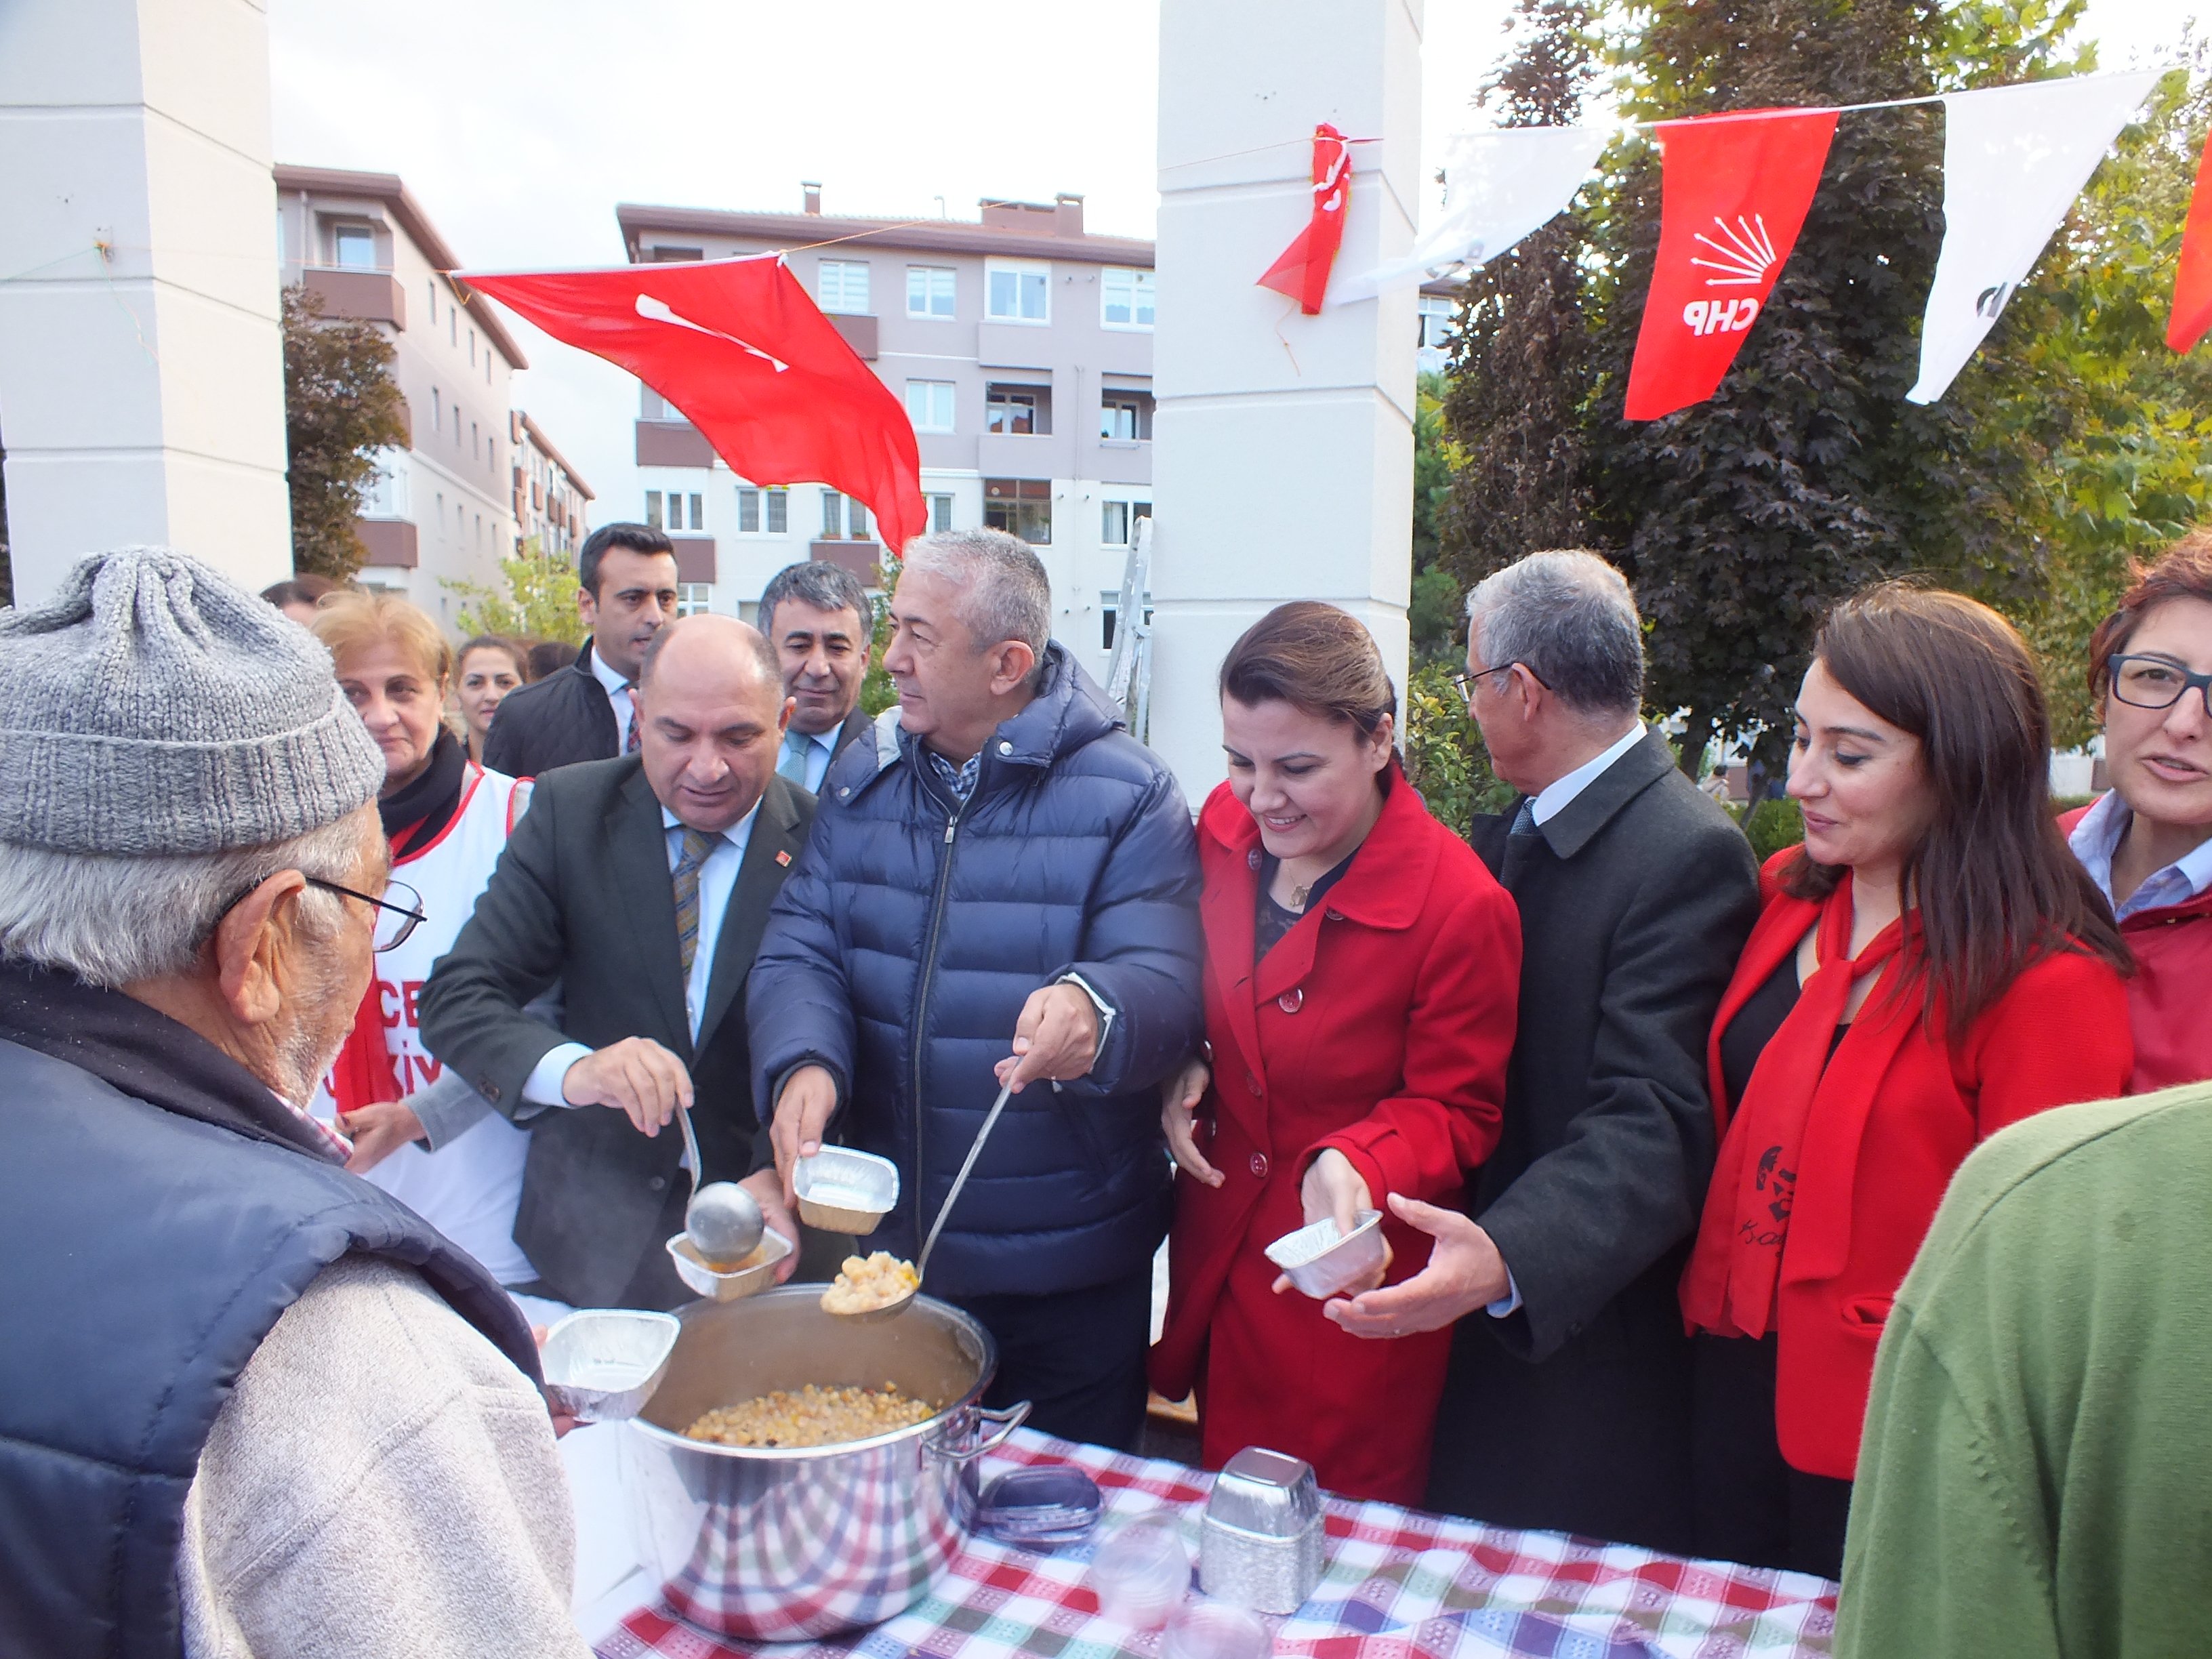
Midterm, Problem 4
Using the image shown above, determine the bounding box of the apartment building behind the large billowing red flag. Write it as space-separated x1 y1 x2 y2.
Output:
617 186 1153 672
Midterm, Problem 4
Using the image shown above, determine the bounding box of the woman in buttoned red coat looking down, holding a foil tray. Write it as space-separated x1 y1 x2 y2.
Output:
1153 602 1519 1504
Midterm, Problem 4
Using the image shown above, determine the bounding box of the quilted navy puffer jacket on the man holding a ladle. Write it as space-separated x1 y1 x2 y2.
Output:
745 644 1206 1296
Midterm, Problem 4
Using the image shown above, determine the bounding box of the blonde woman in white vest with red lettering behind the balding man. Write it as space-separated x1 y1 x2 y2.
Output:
314 593 537 1288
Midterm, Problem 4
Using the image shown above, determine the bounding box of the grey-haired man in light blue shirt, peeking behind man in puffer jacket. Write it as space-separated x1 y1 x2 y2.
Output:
761 560 876 794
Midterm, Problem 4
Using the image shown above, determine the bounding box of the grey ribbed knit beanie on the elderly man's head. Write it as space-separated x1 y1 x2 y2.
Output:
0 546 385 854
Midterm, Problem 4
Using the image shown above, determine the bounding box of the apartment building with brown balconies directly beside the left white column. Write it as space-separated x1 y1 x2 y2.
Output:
276 166 562 628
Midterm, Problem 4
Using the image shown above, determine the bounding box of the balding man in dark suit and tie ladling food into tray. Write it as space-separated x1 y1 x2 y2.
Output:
420 617 814 1307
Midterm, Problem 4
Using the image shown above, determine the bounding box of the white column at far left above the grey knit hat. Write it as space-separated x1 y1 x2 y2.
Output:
0 0 292 604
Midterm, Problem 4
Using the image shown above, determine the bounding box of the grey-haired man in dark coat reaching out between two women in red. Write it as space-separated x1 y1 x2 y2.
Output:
1330 553 1759 1551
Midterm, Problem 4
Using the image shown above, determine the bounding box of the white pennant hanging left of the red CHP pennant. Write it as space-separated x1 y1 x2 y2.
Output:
1330 126 1610 305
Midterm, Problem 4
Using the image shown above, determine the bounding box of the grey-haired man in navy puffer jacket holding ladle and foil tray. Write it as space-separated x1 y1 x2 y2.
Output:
747 531 1204 1449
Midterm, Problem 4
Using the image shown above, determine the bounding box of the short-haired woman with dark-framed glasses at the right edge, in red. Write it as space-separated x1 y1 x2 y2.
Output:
2062 531 2212 1095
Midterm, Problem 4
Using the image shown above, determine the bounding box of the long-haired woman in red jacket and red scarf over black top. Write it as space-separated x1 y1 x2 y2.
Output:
1681 584 2132 1577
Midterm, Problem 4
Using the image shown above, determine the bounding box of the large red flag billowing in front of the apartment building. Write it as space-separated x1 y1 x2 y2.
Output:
455 254 927 553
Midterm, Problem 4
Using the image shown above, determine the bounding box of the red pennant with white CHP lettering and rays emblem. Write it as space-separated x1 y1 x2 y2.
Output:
1626 108 1836 420
